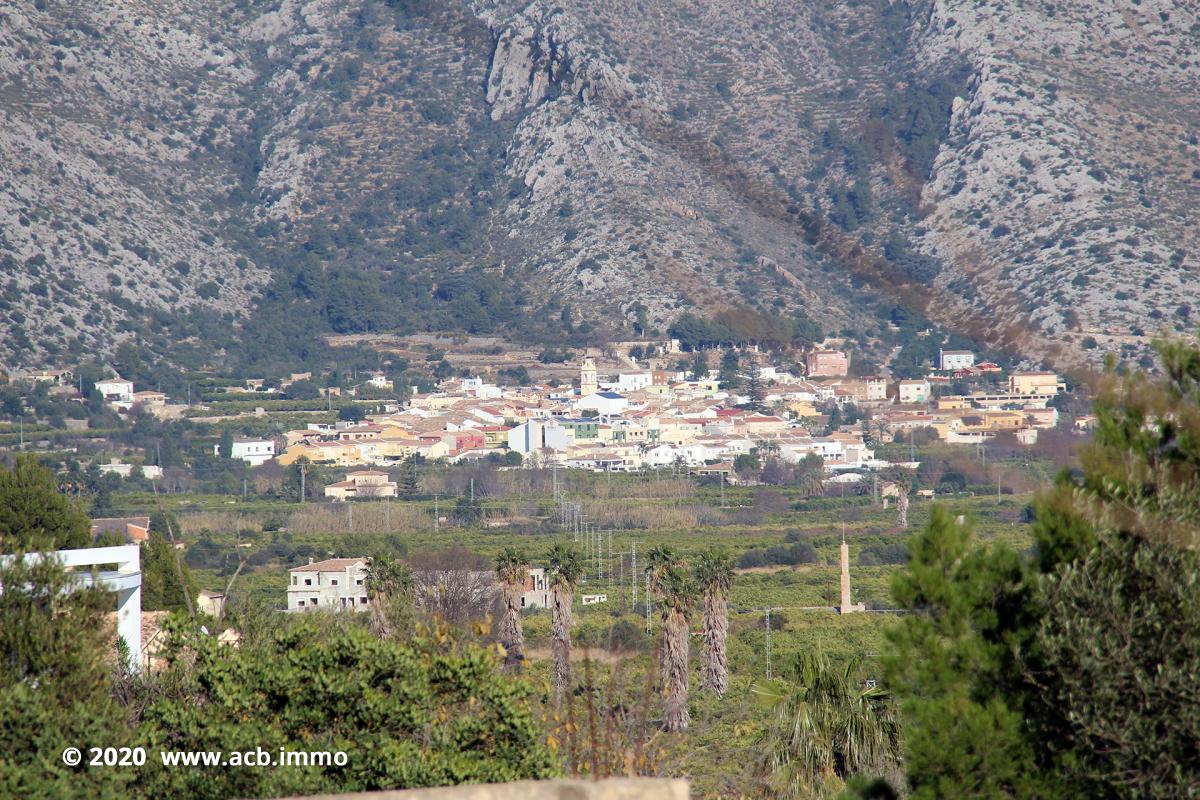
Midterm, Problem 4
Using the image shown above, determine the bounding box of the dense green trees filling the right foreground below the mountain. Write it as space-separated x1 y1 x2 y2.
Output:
888 343 1200 798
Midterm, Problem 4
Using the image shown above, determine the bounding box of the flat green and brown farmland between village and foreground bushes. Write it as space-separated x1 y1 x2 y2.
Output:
103 462 1051 796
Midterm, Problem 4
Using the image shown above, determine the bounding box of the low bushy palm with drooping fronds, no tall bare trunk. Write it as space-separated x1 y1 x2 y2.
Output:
751 651 900 798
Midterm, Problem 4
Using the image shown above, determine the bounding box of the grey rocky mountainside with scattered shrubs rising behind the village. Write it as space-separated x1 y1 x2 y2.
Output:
0 0 1200 365
